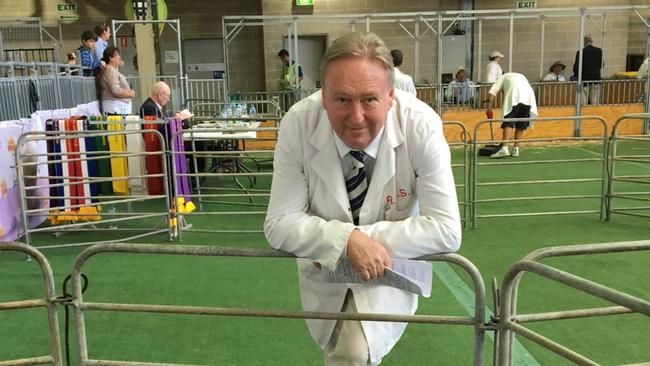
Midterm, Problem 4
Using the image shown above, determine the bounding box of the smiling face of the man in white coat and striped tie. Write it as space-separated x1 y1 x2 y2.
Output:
323 57 394 150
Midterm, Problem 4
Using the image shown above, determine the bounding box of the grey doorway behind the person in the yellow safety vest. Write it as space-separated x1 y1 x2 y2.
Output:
282 35 327 89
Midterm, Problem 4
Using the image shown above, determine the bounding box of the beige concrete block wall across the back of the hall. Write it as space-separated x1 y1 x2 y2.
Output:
0 0 650 90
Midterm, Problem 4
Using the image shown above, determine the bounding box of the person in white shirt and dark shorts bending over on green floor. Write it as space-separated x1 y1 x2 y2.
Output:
486 72 537 158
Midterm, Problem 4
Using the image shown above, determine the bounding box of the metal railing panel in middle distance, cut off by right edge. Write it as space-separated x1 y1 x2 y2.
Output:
607 113 650 221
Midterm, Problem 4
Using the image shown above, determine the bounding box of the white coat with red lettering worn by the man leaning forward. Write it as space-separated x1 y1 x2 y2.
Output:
264 90 461 362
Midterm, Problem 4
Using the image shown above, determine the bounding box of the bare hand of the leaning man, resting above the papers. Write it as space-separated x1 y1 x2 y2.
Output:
347 230 393 281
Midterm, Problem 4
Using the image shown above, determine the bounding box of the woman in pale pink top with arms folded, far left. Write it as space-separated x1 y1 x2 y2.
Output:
99 46 135 115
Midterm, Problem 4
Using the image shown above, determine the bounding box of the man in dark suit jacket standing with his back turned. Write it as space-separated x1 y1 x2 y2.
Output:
573 35 603 105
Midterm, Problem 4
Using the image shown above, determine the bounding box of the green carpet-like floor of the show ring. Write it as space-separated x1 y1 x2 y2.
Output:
0 143 650 365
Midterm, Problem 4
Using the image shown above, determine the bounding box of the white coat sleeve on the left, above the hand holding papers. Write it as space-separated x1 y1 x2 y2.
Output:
264 112 354 270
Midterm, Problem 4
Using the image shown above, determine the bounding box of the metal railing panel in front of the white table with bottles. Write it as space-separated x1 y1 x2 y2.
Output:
171 116 280 239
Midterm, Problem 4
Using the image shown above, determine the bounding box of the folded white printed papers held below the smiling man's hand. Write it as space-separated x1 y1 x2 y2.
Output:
321 259 433 297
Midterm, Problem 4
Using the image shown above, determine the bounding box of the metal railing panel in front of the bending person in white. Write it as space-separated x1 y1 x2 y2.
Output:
471 116 608 228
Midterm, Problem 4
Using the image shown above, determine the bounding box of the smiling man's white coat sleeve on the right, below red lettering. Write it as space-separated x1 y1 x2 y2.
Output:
360 112 461 258
